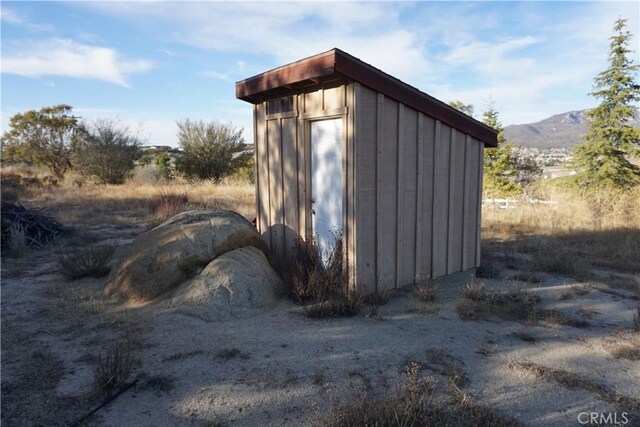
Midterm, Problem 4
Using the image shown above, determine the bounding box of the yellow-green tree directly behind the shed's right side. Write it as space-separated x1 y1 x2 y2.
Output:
482 105 522 197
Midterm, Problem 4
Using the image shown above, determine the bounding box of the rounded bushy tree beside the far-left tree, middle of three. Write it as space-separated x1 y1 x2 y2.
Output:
74 120 141 184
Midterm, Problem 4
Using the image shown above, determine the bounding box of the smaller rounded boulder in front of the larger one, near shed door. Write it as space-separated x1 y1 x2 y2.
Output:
169 246 282 320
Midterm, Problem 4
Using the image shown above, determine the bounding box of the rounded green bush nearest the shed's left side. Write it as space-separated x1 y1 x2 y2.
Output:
176 119 252 182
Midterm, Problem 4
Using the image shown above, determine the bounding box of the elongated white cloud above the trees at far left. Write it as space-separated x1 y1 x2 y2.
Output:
1 39 152 87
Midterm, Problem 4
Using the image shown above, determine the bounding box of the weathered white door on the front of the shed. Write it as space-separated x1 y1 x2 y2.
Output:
311 118 342 264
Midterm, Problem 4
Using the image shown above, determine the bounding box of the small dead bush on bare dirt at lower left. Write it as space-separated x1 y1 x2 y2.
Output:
94 345 134 391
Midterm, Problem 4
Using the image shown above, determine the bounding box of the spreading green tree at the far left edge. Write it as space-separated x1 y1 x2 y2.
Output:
2 104 82 178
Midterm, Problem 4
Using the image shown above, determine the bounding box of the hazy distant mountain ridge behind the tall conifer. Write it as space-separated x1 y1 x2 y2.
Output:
504 110 640 149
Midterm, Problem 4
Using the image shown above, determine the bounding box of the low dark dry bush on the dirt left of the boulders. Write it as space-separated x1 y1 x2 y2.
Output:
58 245 115 280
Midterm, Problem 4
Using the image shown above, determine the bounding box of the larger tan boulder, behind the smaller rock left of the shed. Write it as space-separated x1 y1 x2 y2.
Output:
105 210 267 302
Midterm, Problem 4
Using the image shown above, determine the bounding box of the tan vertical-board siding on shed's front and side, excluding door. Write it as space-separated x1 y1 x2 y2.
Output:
254 82 483 293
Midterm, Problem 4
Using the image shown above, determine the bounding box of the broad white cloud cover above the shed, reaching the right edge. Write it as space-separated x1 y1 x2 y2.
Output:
76 2 640 124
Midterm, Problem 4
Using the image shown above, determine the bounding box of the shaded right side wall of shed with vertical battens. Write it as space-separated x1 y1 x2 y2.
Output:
354 83 482 292
